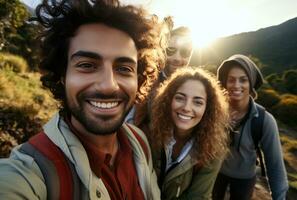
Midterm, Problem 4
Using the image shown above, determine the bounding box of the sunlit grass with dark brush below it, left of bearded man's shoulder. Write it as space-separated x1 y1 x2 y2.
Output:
0 67 57 157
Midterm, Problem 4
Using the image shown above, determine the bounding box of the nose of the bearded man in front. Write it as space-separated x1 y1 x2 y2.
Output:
95 65 119 94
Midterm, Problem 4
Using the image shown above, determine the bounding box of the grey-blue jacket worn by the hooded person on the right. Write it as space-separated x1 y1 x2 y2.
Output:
220 98 288 200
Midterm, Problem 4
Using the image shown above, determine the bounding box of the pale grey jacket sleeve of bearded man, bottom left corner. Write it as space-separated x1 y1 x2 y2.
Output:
0 146 46 200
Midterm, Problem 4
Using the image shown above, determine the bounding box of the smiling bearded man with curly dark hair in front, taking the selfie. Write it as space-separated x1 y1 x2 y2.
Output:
0 0 163 200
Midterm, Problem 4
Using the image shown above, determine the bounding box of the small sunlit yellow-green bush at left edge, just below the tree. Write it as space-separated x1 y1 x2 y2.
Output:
0 53 28 73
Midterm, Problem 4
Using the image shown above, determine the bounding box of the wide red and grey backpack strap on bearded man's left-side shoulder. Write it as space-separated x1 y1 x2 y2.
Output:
20 132 81 200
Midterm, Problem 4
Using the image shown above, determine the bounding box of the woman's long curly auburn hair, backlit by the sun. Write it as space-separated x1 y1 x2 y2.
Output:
150 67 229 166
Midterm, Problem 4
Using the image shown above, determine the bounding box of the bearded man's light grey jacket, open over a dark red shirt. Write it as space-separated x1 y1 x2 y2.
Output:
0 114 160 200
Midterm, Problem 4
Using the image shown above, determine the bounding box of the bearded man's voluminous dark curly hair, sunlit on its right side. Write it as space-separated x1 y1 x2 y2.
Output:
35 0 165 108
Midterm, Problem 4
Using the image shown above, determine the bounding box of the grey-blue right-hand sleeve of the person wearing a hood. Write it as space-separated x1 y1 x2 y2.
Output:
260 112 288 200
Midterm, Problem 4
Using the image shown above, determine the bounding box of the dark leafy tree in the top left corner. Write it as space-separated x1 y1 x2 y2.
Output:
0 0 39 69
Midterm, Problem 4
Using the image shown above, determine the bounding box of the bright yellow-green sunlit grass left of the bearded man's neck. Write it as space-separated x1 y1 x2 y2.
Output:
0 68 57 119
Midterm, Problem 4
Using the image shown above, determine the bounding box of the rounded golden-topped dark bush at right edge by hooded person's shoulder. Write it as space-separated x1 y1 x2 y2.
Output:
273 94 297 127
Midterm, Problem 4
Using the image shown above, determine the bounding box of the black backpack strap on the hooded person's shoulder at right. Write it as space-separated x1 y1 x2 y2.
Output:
251 104 266 177
